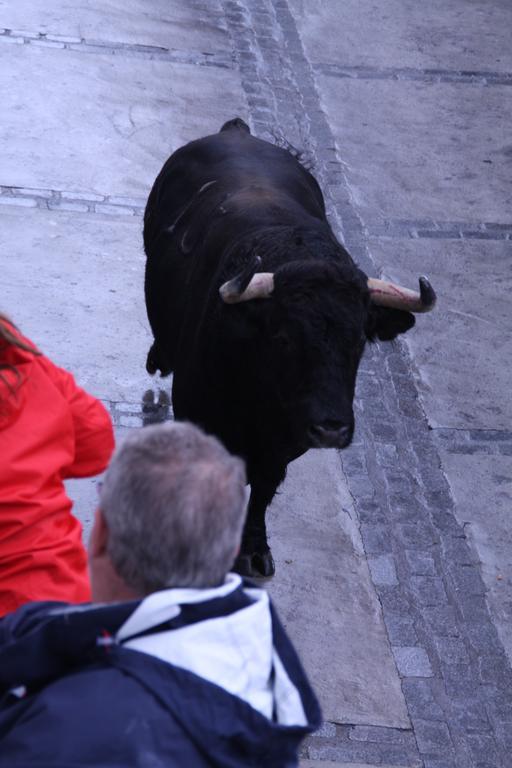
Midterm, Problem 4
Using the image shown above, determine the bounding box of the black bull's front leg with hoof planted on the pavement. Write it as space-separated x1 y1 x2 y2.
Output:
233 471 284 578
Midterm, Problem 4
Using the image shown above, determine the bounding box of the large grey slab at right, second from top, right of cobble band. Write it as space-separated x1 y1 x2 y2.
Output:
318 74 512 222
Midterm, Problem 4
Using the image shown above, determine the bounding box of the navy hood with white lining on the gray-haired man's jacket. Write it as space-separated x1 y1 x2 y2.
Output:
0 574 321 768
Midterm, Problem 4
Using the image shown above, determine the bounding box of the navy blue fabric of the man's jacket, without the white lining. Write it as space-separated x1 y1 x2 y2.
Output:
0 584 321 768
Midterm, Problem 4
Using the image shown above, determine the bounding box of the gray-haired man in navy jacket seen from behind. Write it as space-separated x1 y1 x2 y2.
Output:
0 423 320 768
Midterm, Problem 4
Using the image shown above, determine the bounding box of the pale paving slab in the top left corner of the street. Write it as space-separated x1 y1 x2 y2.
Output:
0 0 230 51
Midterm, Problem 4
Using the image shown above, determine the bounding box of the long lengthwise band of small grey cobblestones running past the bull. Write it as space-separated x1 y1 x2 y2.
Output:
223 0 512 768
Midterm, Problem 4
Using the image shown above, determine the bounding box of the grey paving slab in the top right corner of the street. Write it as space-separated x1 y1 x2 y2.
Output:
291 0 512 72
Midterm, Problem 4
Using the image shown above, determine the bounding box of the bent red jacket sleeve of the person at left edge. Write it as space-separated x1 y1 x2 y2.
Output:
37 357 114 477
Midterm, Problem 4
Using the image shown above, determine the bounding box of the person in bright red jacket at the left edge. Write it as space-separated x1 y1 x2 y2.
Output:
0 313 114 616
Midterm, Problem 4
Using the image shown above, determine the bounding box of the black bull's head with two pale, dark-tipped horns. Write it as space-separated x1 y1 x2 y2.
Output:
219 256 436 449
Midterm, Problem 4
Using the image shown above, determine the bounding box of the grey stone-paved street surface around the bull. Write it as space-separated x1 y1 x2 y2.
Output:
0 0 512 768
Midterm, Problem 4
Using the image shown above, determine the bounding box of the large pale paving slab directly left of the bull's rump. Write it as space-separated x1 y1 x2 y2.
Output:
0 45 246 198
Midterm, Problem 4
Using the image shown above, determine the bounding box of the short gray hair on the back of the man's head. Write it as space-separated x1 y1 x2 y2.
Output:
100 423 246 594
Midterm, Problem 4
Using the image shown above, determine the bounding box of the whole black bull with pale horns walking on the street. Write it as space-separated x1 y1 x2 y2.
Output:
144 118 435 576
